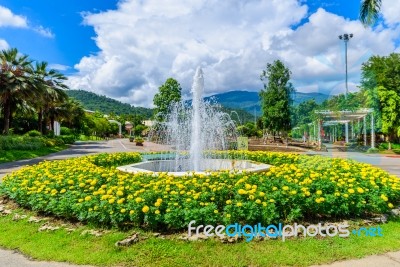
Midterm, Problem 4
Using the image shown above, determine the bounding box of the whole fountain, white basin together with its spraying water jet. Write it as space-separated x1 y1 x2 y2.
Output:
117 67 270 176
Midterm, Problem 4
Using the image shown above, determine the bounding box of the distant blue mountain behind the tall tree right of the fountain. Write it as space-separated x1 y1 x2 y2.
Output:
205 91 329 116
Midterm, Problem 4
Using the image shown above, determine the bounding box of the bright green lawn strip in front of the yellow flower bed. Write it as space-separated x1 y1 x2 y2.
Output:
0 206 400 266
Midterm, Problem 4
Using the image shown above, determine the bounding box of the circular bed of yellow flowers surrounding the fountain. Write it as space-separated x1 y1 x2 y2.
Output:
0 151 400 230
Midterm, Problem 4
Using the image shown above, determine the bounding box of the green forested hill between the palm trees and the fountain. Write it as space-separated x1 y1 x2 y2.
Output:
65 90 153 119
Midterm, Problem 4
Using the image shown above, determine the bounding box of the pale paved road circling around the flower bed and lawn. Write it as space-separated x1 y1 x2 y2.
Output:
0 139 400 267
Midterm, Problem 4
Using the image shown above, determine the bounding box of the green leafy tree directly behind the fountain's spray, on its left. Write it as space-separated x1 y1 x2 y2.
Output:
153 78 182 121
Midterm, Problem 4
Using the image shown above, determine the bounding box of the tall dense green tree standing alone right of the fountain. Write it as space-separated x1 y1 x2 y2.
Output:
260 60 294 139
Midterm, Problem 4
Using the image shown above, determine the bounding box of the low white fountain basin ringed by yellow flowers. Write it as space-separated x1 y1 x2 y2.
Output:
117 159 271 176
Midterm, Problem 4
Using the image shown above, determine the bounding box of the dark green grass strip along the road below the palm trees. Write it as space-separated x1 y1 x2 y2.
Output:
0 145 68 163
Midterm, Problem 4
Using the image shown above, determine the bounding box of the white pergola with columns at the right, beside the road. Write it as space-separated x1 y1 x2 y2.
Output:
314 108 375 148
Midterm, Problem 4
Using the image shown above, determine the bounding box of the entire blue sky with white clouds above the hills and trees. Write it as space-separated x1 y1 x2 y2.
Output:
0 0 400 107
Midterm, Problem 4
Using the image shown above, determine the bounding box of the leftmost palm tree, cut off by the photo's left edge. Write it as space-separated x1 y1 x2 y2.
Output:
0 48 33 134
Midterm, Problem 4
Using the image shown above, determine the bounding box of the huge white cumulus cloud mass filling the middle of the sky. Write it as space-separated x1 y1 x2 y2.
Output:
69 0 398 106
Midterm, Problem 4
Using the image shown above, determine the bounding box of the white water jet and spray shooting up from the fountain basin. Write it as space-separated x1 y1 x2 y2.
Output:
150 67 237 172
